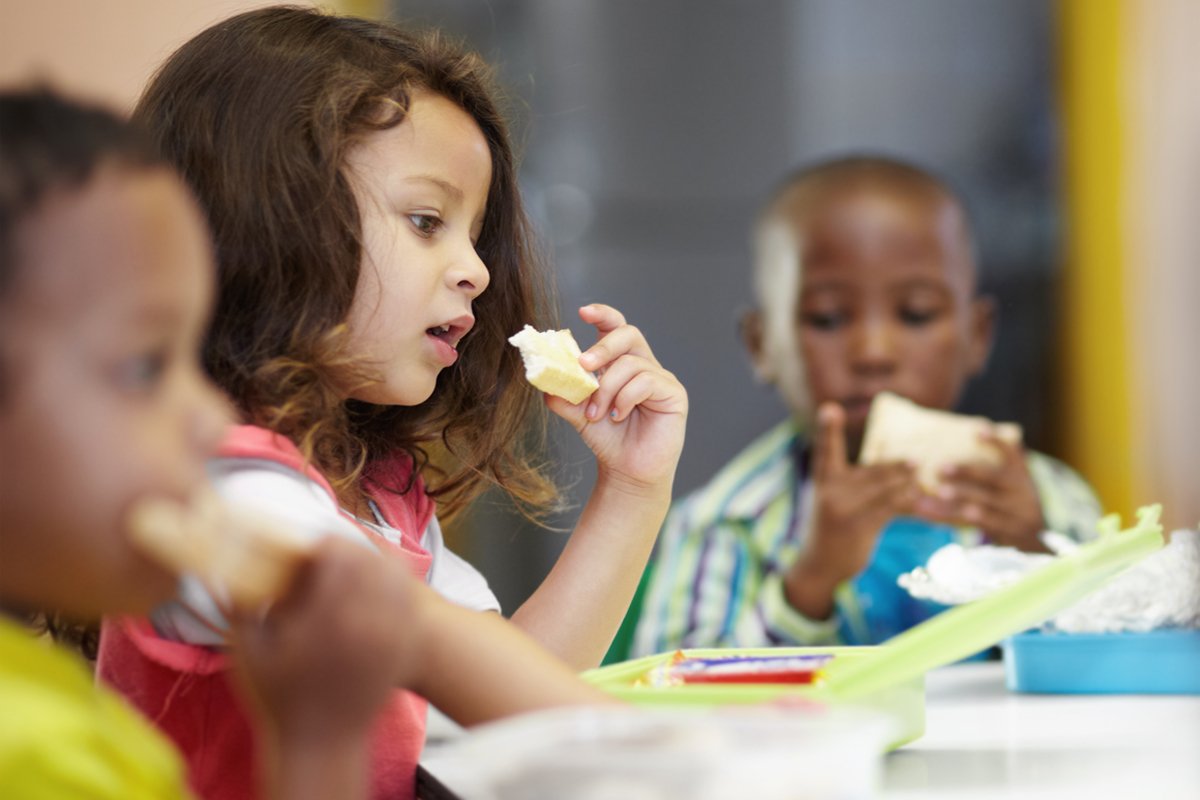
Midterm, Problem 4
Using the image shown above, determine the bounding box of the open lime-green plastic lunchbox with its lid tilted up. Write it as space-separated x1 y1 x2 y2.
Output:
583 506 1163 750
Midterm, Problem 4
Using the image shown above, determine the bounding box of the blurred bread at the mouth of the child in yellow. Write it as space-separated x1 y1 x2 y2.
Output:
126 495 314 609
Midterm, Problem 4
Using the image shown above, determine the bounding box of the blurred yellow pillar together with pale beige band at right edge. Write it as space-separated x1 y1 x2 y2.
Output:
1056 0 1200 527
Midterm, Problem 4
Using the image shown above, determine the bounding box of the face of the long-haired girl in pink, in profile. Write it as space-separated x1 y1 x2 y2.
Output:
347 92 492 405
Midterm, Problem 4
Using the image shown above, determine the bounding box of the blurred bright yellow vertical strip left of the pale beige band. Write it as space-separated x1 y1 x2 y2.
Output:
1056 0 1135 520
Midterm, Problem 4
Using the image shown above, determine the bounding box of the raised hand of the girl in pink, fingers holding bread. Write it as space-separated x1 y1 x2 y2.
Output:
546 303 688 493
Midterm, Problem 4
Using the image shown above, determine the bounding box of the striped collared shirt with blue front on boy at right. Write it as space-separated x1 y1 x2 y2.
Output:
632 420 1100 655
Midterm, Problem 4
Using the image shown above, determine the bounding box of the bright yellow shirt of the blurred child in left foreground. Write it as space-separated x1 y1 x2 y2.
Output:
0 618 192 800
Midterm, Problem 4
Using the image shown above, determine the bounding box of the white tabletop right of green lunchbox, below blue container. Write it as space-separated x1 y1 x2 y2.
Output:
882 662 1200 800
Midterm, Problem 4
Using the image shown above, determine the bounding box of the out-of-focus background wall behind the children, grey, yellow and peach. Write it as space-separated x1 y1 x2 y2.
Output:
0 0 1200 609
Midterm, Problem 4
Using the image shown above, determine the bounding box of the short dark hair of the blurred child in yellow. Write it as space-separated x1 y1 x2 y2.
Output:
0 86 166 658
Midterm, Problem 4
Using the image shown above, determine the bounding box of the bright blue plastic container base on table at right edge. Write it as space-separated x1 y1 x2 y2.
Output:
1003 630 1200 694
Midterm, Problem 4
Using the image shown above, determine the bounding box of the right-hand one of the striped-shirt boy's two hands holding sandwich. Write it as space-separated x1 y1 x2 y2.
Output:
913 433 1045 552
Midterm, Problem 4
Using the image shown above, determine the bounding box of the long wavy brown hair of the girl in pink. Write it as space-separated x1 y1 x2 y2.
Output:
134 7 557 516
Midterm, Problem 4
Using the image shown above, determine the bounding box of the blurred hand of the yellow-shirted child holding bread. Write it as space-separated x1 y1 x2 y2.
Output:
230 537 420 746
